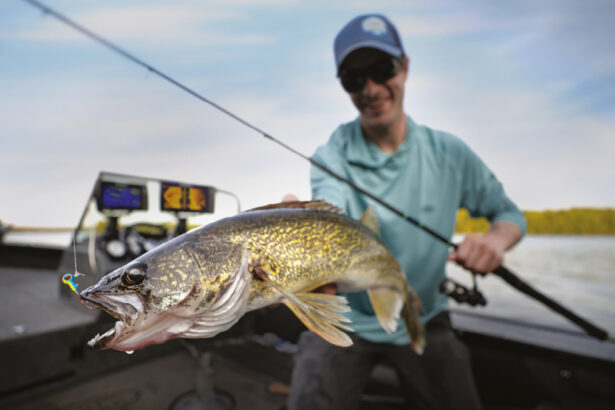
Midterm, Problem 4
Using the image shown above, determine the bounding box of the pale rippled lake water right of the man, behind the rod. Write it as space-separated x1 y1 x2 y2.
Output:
447 235 615 334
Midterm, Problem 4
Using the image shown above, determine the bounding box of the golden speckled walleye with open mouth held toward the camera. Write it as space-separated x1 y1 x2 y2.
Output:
81 201 425 352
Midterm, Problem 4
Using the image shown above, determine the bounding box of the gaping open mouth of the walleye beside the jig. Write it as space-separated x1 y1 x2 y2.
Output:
81 289 143 350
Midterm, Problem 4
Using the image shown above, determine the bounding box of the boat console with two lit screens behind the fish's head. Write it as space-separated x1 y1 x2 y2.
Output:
59 172 221 297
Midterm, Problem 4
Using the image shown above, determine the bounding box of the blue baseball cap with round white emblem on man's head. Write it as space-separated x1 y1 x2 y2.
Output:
333 14 406 72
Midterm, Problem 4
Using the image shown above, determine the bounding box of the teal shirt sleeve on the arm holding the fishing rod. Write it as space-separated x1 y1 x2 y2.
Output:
460 139 527 234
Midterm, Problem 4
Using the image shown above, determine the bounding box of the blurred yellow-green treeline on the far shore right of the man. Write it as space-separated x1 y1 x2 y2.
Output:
455 208 615 235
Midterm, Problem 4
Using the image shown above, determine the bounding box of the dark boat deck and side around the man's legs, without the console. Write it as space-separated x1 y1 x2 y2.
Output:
0 247 615 410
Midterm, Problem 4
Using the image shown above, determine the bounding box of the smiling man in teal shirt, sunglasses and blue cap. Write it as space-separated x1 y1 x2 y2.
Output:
288 15 525 410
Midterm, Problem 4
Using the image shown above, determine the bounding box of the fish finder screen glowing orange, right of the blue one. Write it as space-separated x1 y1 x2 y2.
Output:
160 182 214 213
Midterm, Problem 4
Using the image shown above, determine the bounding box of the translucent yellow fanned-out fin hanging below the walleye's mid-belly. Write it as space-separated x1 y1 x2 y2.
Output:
282 293 352 347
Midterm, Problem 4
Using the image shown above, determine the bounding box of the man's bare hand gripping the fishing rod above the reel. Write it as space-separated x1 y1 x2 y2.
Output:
448 221 521 275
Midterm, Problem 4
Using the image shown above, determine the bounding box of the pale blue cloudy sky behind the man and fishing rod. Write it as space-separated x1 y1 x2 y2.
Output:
0 0 615 226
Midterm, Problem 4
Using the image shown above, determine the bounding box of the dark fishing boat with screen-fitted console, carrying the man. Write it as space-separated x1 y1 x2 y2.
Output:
0 172 615 410
